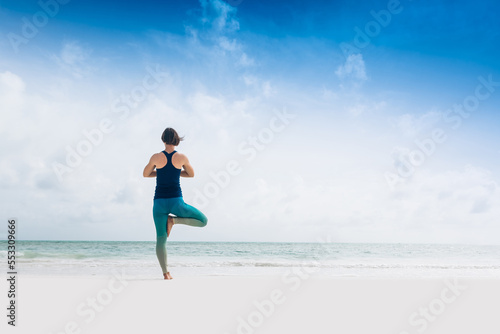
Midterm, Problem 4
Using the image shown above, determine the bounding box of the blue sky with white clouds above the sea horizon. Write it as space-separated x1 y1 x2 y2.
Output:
0 0 500 243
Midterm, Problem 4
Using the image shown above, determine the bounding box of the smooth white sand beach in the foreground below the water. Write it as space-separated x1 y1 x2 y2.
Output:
0 276 500 334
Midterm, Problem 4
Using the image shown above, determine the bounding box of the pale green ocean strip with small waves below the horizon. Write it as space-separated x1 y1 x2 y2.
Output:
0 241 500 279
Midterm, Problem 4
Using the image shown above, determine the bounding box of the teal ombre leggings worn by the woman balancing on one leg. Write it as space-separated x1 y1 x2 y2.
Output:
153 197 208 273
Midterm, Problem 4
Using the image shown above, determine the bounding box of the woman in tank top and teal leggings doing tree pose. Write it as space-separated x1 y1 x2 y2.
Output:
143 128 207 280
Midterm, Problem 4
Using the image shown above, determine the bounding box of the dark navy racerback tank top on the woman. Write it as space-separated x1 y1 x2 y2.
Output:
154 151 182 199
